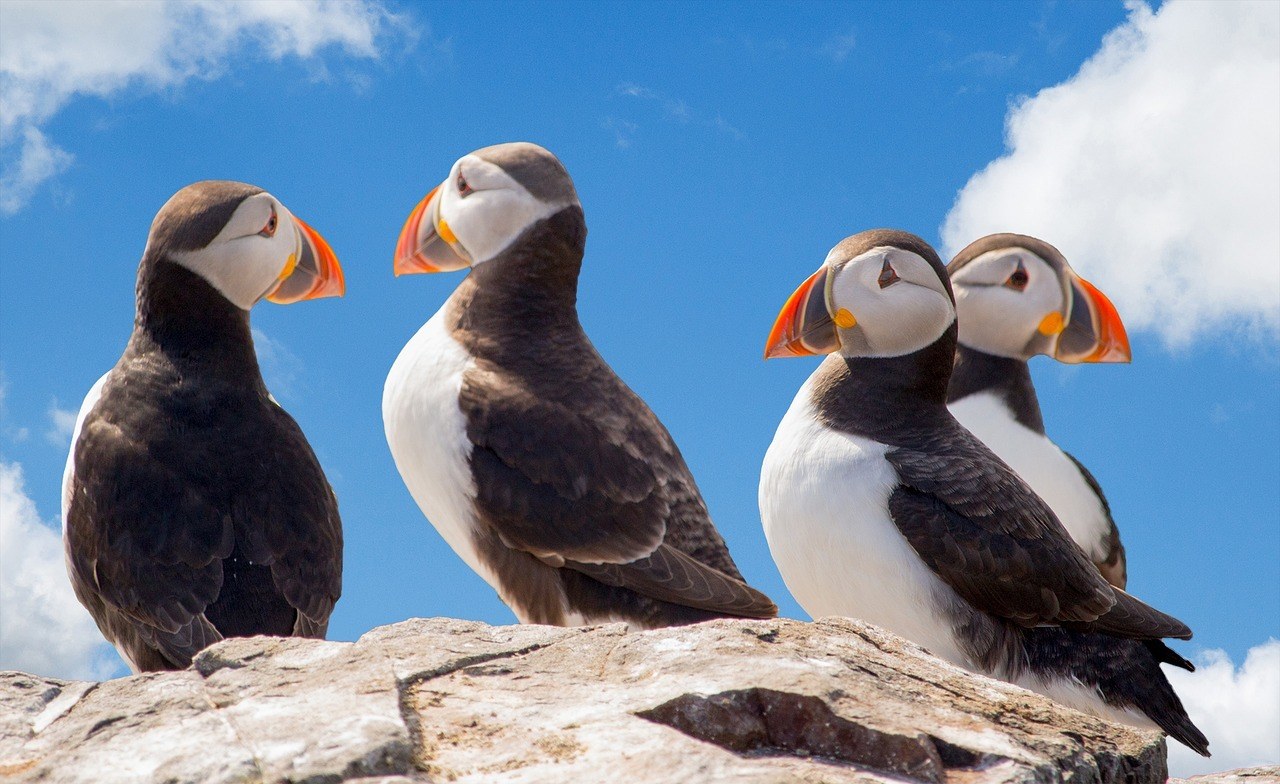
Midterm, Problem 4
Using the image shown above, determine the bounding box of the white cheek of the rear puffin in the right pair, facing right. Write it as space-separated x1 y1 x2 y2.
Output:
952 249 1064 359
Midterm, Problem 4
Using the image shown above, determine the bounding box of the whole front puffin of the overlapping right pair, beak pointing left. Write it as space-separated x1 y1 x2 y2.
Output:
759 229 1208 753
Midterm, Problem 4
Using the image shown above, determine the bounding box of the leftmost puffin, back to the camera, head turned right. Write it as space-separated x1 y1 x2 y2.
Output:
61 181 344 673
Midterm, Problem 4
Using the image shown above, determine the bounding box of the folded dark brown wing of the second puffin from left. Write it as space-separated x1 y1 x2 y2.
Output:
460 368 777 617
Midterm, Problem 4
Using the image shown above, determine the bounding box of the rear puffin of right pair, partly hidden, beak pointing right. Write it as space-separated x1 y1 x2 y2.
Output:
947 233 1133 588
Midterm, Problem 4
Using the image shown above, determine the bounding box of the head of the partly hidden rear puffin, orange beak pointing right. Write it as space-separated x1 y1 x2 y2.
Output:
947 234 1132 364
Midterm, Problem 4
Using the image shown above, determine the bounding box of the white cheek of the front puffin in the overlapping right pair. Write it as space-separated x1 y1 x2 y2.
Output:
832 247 955 357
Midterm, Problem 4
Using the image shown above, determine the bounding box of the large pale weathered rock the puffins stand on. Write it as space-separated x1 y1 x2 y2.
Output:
0 619 1177 784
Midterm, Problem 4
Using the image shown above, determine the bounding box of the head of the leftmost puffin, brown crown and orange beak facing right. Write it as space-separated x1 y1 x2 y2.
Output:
140 179 346 310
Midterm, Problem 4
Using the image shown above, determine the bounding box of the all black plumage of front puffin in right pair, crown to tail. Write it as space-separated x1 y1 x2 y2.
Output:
793 232 1208 755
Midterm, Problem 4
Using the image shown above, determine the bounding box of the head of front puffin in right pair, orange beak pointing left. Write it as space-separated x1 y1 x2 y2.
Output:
764 229 956 359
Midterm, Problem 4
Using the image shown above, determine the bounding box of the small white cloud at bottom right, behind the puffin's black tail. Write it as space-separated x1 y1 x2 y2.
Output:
1165 639 1280 776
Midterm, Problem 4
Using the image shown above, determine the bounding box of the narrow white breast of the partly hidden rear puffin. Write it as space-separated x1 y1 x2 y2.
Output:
948 392 1111 561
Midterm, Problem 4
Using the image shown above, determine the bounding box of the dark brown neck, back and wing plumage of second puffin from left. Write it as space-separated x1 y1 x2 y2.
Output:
447 205 777 626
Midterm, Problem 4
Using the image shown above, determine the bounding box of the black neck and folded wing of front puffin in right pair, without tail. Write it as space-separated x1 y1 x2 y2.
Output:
814 345 1190 639
